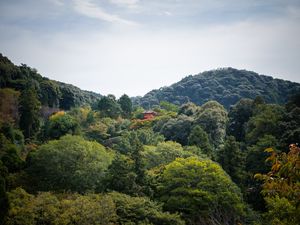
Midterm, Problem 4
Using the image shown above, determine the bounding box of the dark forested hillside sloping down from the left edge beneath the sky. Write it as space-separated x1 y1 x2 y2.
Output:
0 53 101 109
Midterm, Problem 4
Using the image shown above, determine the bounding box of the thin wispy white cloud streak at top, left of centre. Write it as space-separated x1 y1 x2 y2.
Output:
74 0 136 25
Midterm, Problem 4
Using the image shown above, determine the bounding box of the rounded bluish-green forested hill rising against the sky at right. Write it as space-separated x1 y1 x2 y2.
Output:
133 68 300 108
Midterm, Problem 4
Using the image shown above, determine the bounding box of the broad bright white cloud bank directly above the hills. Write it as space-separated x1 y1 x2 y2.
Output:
0 12 300 96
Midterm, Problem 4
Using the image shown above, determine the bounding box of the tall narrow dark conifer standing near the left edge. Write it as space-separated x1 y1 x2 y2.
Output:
19 88 41 138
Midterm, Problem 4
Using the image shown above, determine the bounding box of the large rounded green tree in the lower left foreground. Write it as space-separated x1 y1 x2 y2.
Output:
27 135 112 193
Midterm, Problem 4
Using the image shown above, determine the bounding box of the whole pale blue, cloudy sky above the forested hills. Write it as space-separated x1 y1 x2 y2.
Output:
0 0 300 97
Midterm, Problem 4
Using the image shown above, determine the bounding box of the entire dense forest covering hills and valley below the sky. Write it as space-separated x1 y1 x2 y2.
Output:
0 55 300 225
